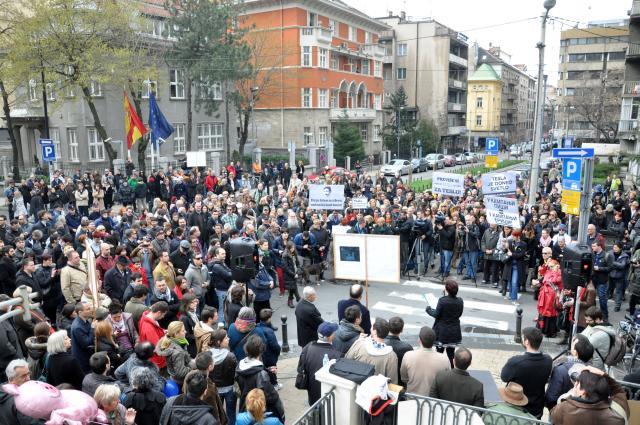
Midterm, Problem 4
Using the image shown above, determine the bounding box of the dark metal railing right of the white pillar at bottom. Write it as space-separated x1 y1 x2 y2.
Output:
396 393 549 425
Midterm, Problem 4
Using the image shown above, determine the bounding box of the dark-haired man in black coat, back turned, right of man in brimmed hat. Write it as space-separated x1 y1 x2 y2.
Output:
500 327 553 419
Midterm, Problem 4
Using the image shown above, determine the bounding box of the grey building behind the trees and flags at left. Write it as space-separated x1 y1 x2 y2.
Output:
0 0 235 171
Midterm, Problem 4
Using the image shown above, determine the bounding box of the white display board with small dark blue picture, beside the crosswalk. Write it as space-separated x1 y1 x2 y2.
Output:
333 233 400 283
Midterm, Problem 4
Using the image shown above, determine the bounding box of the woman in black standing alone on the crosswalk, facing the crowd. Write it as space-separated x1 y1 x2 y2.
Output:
427 279 464 367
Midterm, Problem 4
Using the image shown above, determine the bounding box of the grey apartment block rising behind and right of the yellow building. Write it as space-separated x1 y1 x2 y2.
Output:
469 44 536 146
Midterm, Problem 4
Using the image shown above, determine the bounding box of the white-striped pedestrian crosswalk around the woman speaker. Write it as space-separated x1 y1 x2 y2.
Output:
370 280 516 333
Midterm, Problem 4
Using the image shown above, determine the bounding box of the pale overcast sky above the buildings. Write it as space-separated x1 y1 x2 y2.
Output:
343 0 632 84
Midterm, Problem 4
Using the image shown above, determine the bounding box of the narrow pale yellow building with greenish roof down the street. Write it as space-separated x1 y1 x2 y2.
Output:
467 63 503 146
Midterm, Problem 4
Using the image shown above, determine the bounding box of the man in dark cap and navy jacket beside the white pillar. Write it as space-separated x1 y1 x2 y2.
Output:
298 322 342 406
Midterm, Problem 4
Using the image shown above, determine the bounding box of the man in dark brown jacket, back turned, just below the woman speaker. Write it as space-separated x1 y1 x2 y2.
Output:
429 347 484 407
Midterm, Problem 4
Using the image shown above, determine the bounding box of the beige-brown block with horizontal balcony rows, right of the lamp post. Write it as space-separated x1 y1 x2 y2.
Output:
555 20 628 142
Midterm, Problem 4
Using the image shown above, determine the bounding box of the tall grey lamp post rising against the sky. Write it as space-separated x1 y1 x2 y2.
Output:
528 0 556 205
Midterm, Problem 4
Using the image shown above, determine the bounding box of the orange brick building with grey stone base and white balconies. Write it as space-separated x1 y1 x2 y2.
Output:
240 0 389 154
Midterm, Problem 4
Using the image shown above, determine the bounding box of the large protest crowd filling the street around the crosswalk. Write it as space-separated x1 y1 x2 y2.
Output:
0 161 640 425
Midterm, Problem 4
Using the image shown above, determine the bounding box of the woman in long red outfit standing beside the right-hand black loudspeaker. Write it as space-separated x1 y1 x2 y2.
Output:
538 260 562 338
